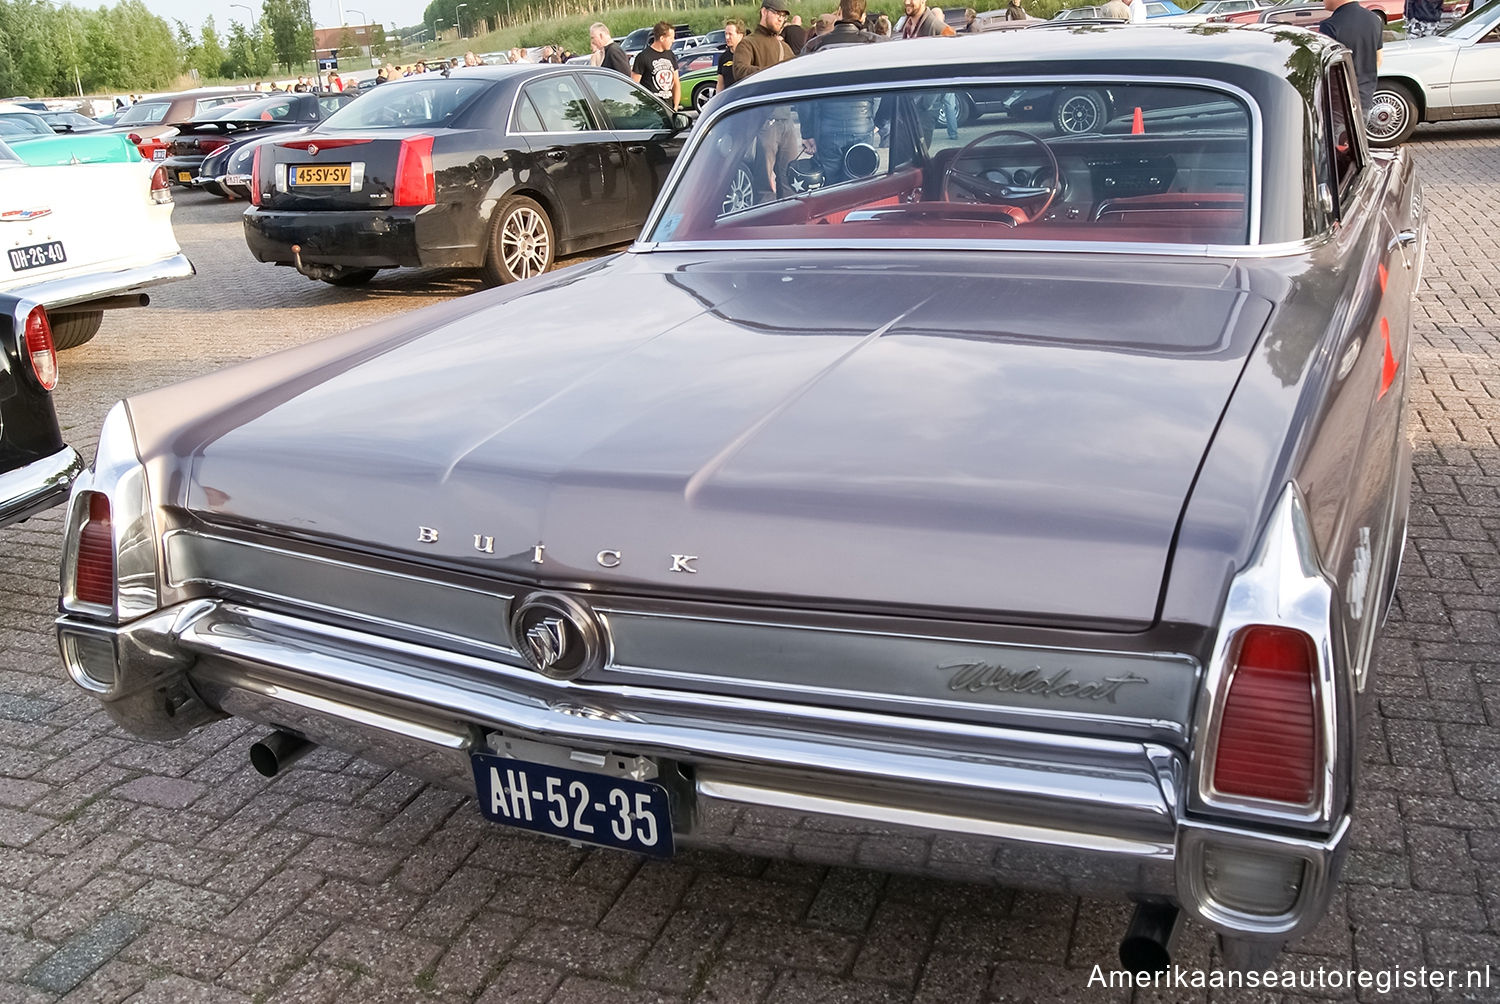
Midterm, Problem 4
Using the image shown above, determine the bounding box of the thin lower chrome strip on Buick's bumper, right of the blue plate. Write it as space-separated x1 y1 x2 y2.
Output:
698 771 1176 861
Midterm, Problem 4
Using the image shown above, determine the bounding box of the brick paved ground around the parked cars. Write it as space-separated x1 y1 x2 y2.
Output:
0 125 1500 1004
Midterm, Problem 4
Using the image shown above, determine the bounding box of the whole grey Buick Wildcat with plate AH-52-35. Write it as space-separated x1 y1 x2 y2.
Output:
57 26 1425 968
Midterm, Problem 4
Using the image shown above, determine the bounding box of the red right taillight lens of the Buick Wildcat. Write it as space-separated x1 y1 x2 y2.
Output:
1214 624 1320 806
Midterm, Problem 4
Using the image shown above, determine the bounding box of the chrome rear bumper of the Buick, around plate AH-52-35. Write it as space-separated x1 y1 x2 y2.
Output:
59 600 1347 938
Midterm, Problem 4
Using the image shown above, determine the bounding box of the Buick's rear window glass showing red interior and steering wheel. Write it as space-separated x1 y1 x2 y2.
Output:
648 81 1253 245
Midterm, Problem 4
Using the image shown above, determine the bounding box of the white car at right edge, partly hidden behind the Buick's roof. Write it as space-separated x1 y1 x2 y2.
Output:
1370 3 1500 147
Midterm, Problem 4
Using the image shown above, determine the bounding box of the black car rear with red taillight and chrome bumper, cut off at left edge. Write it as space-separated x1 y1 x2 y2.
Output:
0 293 84 527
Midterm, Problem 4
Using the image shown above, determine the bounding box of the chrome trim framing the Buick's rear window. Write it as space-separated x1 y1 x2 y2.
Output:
632 68 1265 246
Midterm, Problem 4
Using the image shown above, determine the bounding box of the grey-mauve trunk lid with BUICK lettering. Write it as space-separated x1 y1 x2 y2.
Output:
188 252 1271 630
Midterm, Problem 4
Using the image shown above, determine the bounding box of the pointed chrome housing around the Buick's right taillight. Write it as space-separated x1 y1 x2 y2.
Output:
1190 482 1349 828
